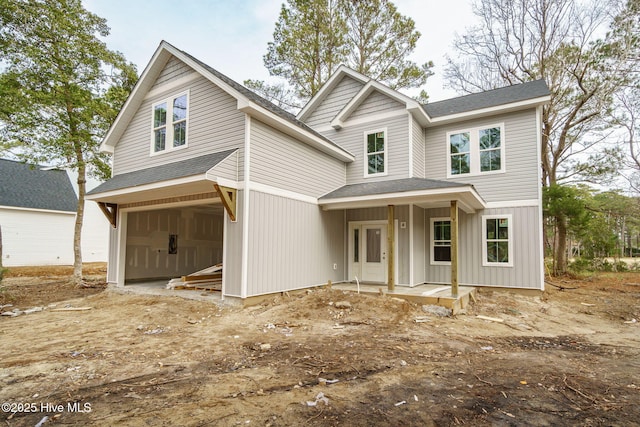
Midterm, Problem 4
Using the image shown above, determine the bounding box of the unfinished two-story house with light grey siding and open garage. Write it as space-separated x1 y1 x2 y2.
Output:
88 42 549 300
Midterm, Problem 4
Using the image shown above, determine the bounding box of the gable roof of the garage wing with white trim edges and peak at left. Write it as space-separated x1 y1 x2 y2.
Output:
101 40 355 162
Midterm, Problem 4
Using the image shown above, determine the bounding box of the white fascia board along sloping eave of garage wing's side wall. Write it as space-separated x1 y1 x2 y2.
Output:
238 99 355 163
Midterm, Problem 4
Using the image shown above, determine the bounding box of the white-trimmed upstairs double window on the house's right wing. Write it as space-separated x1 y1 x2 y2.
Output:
447 124 504 177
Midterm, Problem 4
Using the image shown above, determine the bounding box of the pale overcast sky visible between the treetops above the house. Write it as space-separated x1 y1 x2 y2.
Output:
83 0 474 101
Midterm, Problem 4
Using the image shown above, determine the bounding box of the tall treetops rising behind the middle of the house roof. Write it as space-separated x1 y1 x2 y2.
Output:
254 0 433 105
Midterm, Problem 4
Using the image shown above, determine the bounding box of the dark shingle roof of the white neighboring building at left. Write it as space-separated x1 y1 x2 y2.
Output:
0 159 78 212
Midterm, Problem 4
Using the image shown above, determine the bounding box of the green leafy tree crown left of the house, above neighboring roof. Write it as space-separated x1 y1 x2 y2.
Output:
0 0 137 178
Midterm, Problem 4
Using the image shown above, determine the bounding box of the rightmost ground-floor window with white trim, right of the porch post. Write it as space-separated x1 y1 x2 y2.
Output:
482 215 513 267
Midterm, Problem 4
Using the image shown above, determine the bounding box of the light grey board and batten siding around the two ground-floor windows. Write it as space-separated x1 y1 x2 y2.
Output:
425 206 542 289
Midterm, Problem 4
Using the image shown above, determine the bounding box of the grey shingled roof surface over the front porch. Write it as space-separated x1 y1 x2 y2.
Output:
319 178 469 201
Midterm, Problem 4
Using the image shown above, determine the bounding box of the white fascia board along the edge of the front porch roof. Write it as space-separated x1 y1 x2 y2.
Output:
318 186 486 213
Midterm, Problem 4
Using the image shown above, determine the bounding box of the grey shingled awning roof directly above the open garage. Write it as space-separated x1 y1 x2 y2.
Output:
87 149 236 194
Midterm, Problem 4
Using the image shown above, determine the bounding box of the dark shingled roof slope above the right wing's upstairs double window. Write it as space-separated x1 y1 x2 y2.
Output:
422 80 549 118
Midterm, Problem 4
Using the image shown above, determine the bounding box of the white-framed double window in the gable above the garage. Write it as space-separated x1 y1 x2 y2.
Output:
151 93 189 153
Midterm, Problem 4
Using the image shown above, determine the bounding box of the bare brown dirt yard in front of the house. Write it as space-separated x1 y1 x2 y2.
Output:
0 266 640 426
